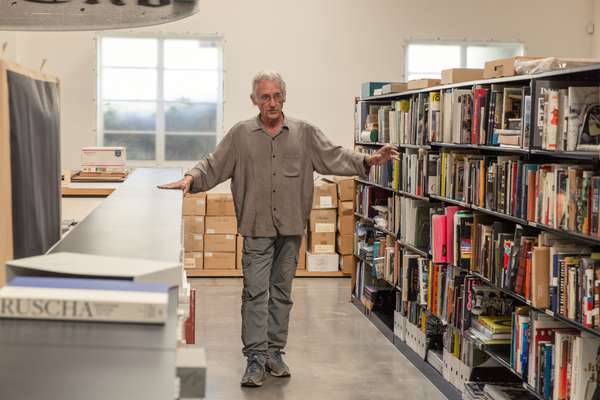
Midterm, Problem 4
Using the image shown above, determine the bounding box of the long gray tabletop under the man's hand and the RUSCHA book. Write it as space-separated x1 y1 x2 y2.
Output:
0 169 182 400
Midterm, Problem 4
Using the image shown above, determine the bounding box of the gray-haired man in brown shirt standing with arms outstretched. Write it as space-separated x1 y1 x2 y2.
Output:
161 72 398 386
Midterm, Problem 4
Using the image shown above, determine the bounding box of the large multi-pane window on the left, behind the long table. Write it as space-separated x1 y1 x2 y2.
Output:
98 36 223 165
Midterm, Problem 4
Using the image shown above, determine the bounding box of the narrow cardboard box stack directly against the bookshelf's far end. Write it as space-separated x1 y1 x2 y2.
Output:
333 177 356 274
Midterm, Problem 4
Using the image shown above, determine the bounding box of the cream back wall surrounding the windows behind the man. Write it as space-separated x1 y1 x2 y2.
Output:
11 0 596 168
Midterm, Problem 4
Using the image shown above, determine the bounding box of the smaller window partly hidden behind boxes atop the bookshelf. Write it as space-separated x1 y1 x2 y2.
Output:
406 41 523 80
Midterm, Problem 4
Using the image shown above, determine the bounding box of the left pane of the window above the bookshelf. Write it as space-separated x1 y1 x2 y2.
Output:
408 44 460 77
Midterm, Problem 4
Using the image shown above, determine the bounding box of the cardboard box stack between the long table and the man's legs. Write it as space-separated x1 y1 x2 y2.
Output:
183 193 243 270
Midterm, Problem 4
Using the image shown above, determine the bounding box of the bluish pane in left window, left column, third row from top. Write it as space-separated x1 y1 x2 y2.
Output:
103 101 156 131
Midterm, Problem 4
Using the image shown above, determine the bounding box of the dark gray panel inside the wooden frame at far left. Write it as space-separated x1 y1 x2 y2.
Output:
7 70 60 258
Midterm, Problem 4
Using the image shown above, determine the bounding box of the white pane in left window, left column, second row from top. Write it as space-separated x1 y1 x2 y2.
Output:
102 68 156 100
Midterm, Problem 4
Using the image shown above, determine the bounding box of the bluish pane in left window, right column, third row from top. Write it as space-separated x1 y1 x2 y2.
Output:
165 103 217 132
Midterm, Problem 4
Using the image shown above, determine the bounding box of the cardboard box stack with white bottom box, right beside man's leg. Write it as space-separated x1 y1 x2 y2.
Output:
306 181 339 272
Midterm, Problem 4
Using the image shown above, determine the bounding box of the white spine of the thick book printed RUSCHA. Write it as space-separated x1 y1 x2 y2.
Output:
0 285 168 324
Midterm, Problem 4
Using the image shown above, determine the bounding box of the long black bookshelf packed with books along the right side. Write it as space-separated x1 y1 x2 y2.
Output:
352 65 600 400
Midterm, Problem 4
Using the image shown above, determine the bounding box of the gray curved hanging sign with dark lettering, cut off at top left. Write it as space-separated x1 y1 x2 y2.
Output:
0 0 198 31
